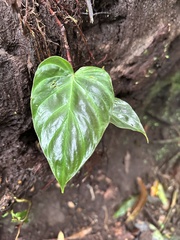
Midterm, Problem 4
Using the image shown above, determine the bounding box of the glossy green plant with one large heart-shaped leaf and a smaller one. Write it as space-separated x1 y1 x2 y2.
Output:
31 56 147 192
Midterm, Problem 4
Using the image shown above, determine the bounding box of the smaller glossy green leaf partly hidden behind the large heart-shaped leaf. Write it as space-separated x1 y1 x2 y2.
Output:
110 98 149 142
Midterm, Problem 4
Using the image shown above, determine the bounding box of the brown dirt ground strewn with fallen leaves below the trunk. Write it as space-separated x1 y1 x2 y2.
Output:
0 70 180 240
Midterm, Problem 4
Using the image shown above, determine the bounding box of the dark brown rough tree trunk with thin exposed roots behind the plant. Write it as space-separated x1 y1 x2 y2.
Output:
0 0 180 212
